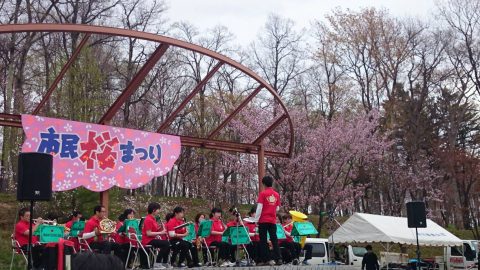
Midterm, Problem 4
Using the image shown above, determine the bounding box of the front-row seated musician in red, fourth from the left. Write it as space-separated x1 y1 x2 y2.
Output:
166 206 200 267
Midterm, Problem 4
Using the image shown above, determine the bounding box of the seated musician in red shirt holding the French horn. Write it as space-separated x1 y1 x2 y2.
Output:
83 205 121 257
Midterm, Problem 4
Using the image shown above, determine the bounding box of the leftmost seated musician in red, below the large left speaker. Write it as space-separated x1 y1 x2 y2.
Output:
15 208 44 268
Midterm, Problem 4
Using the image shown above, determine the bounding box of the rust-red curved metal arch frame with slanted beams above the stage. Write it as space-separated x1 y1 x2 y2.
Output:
0 24 294 209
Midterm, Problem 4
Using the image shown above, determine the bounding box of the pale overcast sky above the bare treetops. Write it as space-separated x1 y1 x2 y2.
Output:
166 0 435 46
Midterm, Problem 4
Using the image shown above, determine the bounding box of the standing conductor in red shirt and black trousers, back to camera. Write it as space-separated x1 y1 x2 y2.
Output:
255 176 282 266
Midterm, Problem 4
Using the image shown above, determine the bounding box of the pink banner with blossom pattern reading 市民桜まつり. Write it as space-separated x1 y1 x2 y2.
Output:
22 115 180 191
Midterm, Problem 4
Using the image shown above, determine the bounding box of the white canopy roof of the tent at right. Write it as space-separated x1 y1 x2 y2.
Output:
328 213 462 246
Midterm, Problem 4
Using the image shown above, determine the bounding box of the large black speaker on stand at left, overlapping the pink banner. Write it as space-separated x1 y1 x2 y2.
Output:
17 153 53 201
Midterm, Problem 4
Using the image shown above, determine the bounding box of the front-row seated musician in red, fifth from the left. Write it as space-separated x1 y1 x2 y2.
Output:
205 207 235 267
